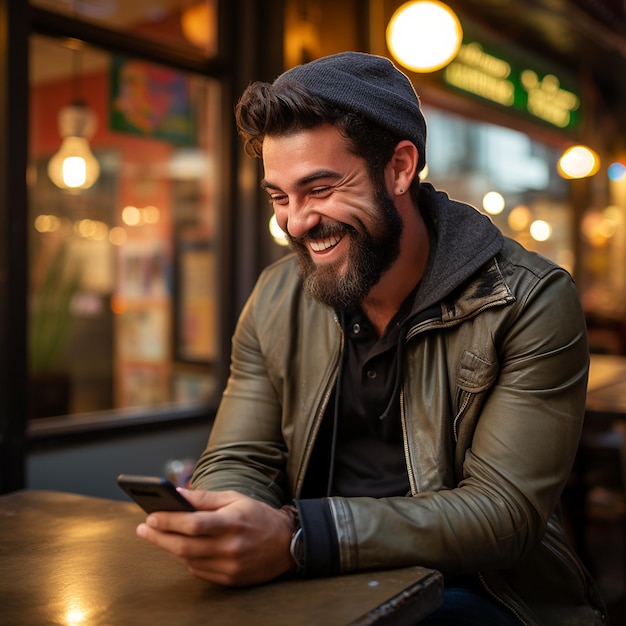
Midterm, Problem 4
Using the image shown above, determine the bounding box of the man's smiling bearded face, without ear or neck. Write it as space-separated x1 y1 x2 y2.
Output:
262 125 402 310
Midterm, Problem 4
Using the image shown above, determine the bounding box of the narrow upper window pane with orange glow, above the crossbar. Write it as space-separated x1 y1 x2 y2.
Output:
31 0 219 57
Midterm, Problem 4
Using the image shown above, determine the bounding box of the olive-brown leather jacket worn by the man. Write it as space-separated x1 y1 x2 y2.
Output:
192 189 605 626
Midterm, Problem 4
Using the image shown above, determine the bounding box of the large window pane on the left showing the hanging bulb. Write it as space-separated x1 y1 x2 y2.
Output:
28 31 219 417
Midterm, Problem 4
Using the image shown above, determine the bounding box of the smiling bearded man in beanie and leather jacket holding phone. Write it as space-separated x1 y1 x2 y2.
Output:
138 52 604 626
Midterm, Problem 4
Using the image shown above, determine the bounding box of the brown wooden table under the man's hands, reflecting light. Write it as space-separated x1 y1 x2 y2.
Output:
0 490 443 626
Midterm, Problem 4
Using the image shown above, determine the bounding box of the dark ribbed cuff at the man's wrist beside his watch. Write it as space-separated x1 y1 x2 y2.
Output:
294 498 339 578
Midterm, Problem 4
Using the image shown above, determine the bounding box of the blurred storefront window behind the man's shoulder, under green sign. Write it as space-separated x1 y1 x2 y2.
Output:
424 107 574 272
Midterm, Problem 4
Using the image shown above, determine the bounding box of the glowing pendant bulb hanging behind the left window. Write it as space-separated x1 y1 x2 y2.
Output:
48 43 100 192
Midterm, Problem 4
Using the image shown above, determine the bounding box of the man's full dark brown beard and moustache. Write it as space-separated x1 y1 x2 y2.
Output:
289 191 403 311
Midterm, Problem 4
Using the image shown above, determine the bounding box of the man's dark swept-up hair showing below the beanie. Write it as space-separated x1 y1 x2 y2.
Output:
235 81 419 203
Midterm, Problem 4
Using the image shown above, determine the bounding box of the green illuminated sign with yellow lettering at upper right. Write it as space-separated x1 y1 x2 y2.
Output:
443 41 581 129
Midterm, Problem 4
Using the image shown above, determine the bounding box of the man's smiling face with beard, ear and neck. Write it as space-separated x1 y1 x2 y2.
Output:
262 124 428 324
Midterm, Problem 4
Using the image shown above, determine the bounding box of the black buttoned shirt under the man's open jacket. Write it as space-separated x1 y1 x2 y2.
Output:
301 288 417 498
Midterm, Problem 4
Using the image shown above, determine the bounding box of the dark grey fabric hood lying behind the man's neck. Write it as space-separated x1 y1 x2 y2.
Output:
414 183 504 313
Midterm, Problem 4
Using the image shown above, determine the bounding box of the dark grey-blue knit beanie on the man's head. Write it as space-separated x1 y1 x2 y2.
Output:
274 52 426 171
